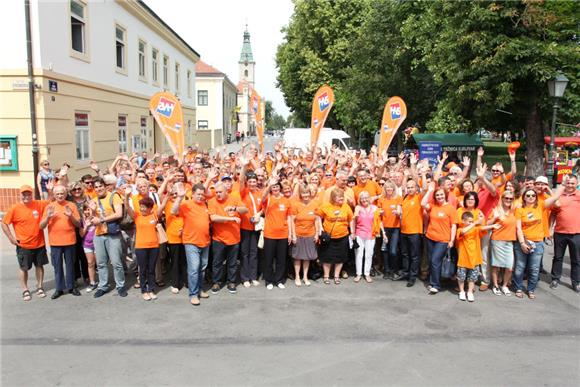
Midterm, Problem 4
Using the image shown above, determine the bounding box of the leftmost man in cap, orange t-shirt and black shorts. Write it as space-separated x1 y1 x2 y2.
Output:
1 185 48 301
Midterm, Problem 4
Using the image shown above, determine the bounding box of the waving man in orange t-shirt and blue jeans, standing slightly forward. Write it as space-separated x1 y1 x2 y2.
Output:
171 183 211 306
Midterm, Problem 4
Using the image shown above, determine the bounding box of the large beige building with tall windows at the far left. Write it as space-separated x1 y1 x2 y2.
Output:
0 0 202 211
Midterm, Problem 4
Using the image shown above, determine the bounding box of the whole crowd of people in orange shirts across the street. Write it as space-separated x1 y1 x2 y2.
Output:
2 142 580 305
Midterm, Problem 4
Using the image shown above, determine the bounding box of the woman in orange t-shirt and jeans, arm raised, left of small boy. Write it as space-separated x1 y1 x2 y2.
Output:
421 182 457 294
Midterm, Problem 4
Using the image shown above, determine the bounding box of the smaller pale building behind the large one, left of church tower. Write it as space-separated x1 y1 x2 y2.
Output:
195 60 237 148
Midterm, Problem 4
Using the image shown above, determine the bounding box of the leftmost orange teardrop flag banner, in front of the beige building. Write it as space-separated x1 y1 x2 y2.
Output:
149 92 185 158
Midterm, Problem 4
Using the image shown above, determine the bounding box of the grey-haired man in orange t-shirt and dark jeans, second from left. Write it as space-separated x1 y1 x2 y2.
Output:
40 185 81 300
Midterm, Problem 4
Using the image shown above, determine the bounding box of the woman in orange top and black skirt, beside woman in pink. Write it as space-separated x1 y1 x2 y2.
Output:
316 188 354 285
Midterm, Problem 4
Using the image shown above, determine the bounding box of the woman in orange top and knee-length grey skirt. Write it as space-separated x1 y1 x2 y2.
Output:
291 185 322 286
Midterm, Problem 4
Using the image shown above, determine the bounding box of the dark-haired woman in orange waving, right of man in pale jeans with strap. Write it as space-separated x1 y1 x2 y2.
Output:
125 192 159 301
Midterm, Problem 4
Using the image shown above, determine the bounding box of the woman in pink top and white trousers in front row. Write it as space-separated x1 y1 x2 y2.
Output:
351 191 387 283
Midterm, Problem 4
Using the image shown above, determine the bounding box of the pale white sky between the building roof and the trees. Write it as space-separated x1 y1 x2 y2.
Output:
144 0 294 117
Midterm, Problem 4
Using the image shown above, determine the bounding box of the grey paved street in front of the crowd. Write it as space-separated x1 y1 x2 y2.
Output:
1 229 580 386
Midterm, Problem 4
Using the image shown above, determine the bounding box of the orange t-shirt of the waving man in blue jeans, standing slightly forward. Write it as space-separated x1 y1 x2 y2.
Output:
179 200 211 248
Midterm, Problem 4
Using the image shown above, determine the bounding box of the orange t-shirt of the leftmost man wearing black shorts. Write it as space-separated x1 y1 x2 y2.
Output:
2 200 49 250
